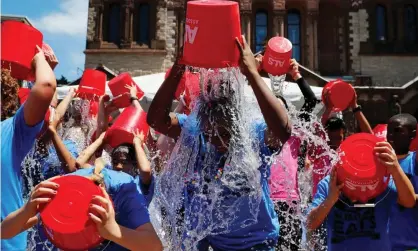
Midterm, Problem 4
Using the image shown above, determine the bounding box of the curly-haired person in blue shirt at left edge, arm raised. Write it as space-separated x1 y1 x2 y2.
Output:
1 47 57 250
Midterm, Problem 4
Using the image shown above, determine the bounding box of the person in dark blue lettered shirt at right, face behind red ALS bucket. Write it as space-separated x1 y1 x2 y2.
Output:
307 142 415 251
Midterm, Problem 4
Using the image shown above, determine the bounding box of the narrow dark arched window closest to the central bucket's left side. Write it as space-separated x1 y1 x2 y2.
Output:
135 3 151 46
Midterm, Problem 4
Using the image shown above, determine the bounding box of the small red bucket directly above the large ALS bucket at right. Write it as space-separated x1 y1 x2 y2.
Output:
322 79 355 112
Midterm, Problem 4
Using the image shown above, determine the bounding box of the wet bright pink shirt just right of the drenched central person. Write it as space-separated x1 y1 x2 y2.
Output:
269 136 301 201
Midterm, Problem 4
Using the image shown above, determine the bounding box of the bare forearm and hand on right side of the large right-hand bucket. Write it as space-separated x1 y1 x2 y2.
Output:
374 142 416 208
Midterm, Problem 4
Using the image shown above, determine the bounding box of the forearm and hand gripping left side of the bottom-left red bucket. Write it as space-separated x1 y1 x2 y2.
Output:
1 179 58 239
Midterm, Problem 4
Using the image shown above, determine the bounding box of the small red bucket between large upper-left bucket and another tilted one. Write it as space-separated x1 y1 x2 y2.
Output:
77 69 106 100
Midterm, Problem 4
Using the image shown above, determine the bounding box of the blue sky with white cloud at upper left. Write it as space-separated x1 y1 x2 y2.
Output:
0 0 88 81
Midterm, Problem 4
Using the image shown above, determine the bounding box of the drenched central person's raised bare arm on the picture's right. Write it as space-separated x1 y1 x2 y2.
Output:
236 37 291 149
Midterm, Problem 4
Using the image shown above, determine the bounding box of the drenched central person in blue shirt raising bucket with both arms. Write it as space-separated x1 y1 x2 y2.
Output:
147 35 291 251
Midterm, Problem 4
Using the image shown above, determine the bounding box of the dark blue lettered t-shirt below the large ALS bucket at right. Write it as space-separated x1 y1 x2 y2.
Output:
311 175 396 251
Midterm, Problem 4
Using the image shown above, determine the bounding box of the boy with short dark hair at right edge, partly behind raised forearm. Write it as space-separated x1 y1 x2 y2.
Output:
387 114 418 251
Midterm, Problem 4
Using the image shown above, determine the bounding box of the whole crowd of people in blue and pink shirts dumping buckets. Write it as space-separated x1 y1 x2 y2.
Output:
1 35 418 251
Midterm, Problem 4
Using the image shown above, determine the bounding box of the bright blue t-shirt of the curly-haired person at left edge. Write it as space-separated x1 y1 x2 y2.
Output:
1 106 43 251
